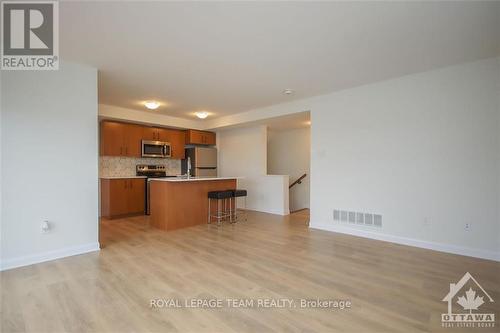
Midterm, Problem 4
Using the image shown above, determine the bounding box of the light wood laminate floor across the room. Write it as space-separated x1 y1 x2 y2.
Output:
0 212 500 332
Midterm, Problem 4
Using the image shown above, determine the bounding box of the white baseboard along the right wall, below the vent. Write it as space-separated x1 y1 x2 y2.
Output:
309 224 500 262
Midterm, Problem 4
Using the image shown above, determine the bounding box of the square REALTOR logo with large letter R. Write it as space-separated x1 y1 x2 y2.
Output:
0 1 59 70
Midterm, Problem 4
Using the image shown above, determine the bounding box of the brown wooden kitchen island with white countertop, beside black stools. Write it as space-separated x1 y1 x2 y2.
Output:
149 177 236 231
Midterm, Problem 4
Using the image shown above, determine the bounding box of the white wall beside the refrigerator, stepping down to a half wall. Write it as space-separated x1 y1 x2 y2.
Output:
217 126 289 215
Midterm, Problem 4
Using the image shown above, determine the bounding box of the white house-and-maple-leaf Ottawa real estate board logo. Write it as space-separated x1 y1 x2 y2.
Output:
441 272 495 328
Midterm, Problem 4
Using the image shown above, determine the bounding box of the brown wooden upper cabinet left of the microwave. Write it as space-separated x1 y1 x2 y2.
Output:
101 121 143 157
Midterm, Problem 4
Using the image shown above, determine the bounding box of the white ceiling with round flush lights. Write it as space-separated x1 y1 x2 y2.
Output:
59 1 500 118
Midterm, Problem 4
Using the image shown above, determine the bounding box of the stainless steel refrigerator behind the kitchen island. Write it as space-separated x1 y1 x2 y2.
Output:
182 147 217 177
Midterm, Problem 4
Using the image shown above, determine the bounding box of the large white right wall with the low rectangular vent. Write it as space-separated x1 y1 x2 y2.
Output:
213 58 500 260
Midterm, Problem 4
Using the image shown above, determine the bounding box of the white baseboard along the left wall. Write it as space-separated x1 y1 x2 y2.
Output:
0 243 100 271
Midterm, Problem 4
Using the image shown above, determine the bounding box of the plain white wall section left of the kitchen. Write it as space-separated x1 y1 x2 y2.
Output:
1 63 99 269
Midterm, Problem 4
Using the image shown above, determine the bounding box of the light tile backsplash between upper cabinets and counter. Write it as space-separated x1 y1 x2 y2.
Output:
99 156 181 177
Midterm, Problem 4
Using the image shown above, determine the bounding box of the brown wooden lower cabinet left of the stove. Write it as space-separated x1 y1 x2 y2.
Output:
101 178 146 218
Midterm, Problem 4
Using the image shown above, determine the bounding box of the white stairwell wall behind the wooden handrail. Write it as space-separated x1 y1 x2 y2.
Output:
267 127 311 211
